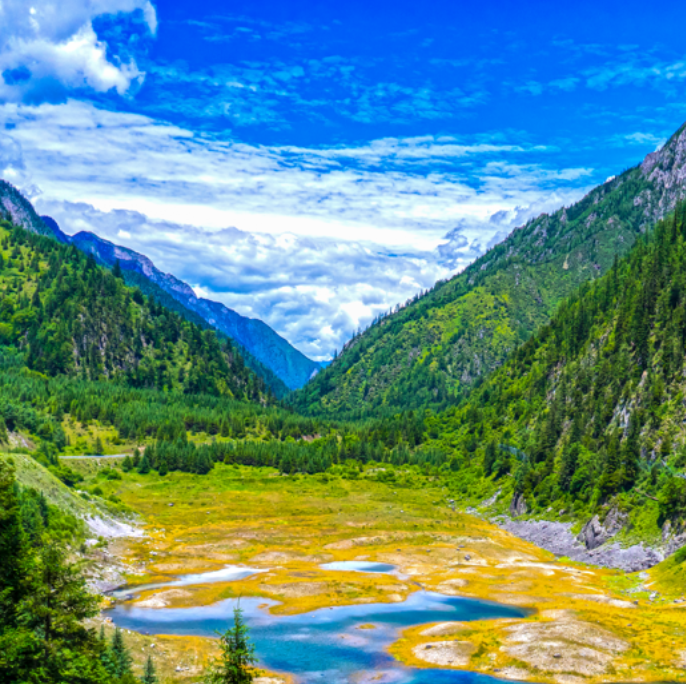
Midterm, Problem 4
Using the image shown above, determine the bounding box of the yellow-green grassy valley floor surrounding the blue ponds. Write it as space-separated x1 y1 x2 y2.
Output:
70 459 686 684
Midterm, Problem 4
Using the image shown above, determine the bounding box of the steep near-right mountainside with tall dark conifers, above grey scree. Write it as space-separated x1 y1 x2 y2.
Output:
430 203 686 552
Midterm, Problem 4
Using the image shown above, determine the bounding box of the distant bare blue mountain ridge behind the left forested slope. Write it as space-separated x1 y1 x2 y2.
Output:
0 181 321 396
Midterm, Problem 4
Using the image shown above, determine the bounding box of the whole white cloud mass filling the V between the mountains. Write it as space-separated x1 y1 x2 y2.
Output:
0 101 589 359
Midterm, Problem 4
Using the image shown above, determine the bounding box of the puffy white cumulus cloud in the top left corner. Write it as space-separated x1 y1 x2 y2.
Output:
0 0 157 103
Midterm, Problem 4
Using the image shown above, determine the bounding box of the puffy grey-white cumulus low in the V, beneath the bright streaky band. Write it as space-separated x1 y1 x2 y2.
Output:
37 198 456 360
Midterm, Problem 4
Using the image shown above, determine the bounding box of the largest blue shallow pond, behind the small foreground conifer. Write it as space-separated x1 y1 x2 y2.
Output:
107 591 527 684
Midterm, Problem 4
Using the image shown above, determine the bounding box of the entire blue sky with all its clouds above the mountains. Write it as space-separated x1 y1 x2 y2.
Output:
0 0 686 359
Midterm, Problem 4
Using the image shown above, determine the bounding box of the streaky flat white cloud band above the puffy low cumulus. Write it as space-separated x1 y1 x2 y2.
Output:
0 101 589 250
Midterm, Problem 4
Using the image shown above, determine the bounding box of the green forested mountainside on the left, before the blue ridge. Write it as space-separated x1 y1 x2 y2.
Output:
0 220 269 404
